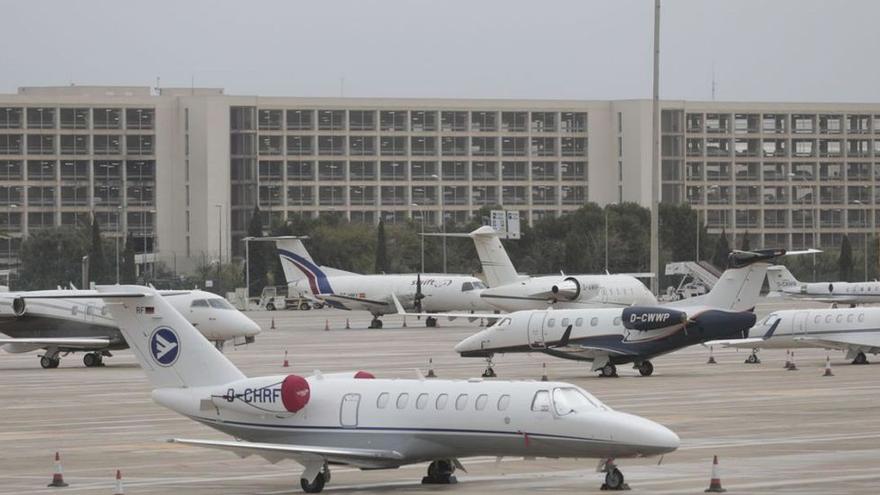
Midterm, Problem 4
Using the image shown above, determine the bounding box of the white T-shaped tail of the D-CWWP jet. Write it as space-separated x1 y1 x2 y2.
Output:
673 250 785 311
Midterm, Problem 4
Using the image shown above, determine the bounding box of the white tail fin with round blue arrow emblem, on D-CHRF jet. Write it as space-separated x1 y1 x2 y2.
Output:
92 285 246 388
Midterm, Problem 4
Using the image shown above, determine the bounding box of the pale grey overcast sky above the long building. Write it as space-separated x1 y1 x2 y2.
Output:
0 0 880 102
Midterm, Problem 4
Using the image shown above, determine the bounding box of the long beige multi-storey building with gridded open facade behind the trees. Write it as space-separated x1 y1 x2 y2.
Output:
0 86 880 271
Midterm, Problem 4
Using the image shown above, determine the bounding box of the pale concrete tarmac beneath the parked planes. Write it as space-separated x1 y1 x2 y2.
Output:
0 301 880 495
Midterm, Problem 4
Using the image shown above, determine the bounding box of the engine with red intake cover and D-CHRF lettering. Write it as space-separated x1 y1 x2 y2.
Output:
211 375 311 415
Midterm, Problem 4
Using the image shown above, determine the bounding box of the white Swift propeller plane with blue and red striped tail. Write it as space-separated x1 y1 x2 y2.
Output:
274 236 494 328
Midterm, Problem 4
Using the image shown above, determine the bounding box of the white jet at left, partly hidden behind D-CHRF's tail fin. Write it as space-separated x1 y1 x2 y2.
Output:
0 290 260 368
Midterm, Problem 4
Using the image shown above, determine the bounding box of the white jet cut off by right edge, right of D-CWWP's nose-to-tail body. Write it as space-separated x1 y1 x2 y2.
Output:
705 307 880 364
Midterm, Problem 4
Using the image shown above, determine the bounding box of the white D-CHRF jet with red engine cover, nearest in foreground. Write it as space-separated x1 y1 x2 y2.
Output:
81 286 680 493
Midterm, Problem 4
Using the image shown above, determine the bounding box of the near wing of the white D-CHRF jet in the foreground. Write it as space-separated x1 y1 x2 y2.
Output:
169 438 403 468
